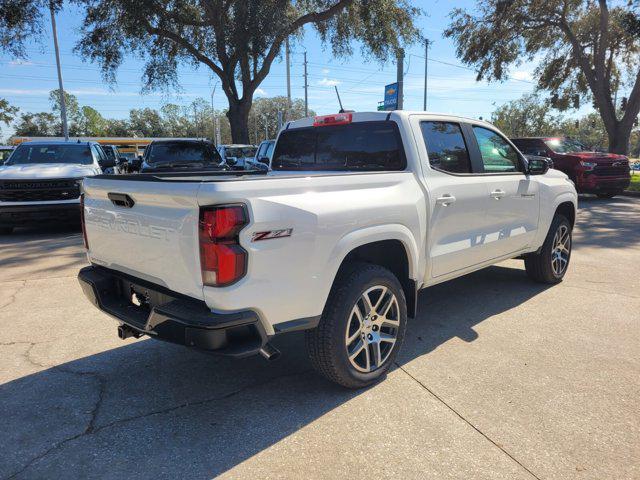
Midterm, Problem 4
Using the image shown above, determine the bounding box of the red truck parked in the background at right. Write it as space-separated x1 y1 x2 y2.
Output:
511 137 631 198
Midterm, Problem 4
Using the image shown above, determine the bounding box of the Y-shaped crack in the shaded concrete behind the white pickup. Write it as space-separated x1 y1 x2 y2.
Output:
6 370 311 480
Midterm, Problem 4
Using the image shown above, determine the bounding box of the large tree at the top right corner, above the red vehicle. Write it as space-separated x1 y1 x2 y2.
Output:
445 0 640 153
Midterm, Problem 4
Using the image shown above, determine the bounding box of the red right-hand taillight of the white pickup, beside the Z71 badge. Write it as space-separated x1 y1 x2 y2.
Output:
199 205 249 287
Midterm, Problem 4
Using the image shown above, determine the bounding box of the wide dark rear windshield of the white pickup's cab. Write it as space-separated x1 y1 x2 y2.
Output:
272 121 407 171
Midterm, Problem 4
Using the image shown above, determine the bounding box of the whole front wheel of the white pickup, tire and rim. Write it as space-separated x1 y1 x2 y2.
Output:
524 215 572 284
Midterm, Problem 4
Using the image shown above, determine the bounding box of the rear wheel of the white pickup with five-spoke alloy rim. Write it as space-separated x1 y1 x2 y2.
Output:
306 264 407 388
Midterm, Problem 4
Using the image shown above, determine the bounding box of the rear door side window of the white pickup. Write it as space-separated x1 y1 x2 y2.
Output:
420 122 471 173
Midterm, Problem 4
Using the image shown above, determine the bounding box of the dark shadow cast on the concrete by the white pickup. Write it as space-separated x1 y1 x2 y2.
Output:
0 263 545 478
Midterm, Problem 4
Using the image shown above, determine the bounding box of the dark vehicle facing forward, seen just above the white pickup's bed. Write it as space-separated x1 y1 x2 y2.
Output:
140 139 228 173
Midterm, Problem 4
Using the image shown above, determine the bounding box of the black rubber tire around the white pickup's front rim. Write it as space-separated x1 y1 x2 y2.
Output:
524 214 573 285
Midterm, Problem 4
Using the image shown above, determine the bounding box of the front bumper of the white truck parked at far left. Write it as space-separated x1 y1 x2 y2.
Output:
0 202 80 227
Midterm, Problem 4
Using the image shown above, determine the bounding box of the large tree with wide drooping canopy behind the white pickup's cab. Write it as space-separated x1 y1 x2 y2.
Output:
72 0 420 143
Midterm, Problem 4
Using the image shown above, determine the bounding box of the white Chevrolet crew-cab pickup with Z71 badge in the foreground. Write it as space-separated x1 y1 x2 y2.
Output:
79 111 577 388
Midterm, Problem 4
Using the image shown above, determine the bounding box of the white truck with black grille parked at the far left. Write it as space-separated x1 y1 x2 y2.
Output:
0 141 114 234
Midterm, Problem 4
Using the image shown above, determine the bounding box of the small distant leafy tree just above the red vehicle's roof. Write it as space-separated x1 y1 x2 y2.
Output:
491 94 561 137
